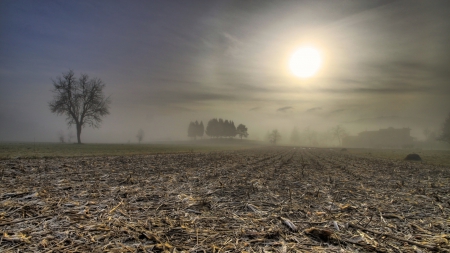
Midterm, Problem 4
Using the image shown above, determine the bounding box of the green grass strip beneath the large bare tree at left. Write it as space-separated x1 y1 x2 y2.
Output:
0 139 261 159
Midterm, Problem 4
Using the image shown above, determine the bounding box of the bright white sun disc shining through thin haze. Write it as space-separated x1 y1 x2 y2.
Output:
289 47 322 78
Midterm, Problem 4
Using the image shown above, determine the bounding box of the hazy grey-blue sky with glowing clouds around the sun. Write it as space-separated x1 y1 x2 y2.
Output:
0 0 450 143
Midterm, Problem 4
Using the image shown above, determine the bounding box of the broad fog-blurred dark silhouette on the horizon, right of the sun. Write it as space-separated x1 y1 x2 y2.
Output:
342 127 413 148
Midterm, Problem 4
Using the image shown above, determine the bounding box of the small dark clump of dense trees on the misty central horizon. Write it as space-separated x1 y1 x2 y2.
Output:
188 118 248 139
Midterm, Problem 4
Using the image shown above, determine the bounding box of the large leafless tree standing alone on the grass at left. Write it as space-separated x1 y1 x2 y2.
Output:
49 70 111 144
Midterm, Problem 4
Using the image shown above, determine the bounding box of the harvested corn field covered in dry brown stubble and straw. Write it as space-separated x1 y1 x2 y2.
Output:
0 147 450 252
